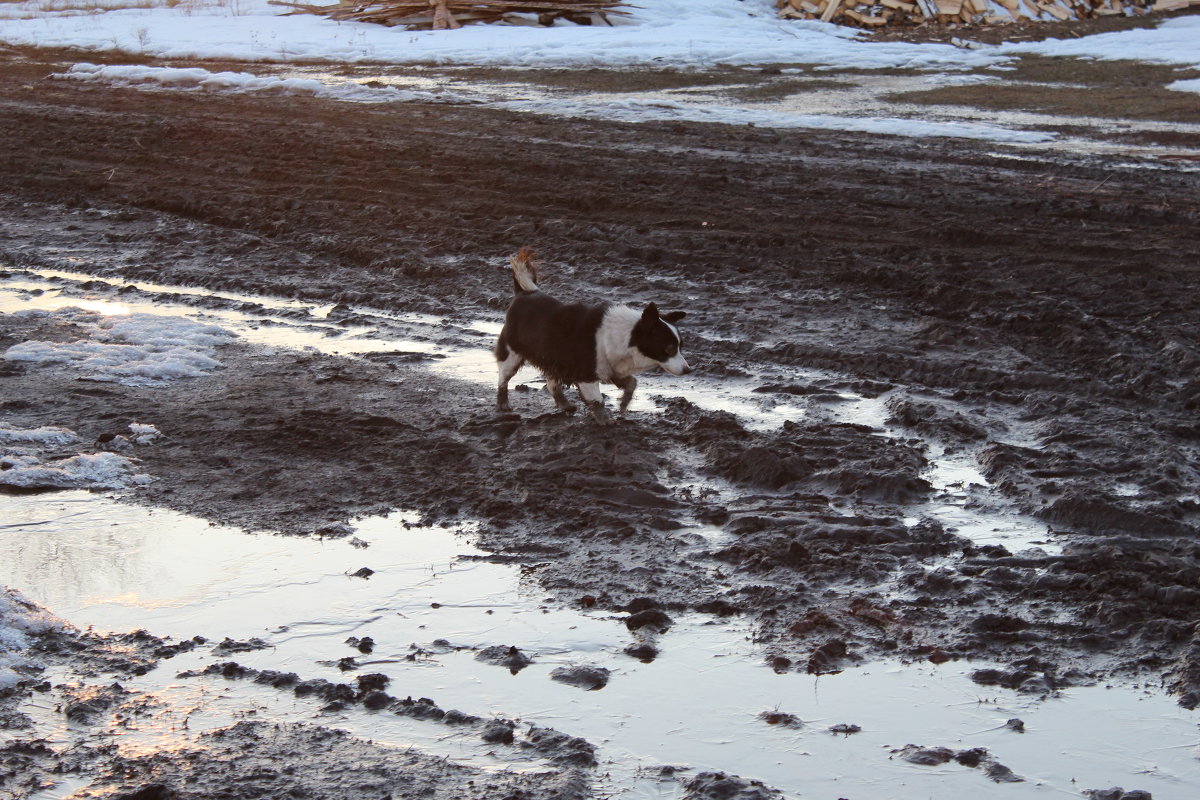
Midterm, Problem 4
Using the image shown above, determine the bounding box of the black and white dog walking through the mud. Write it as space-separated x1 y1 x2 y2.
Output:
496 247 691 425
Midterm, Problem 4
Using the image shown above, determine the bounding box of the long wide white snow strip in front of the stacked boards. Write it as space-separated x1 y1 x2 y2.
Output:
0 0 1002 70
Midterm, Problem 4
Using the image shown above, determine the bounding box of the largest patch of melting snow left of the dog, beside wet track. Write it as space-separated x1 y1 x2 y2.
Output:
4 308 233 386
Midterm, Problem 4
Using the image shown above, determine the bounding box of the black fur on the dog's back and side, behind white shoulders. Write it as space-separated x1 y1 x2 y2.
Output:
496 291 608 385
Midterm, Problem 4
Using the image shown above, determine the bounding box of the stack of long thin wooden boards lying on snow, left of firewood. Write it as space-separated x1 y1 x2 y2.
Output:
271 0 628 30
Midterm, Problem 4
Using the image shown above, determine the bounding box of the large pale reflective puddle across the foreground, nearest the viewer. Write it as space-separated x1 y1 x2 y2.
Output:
0 492 1200 800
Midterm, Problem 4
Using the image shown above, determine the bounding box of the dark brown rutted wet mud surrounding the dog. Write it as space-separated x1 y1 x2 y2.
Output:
0 35 1200 796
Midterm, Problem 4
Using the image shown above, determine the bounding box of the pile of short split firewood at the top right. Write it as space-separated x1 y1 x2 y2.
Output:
775 0 1200 28
